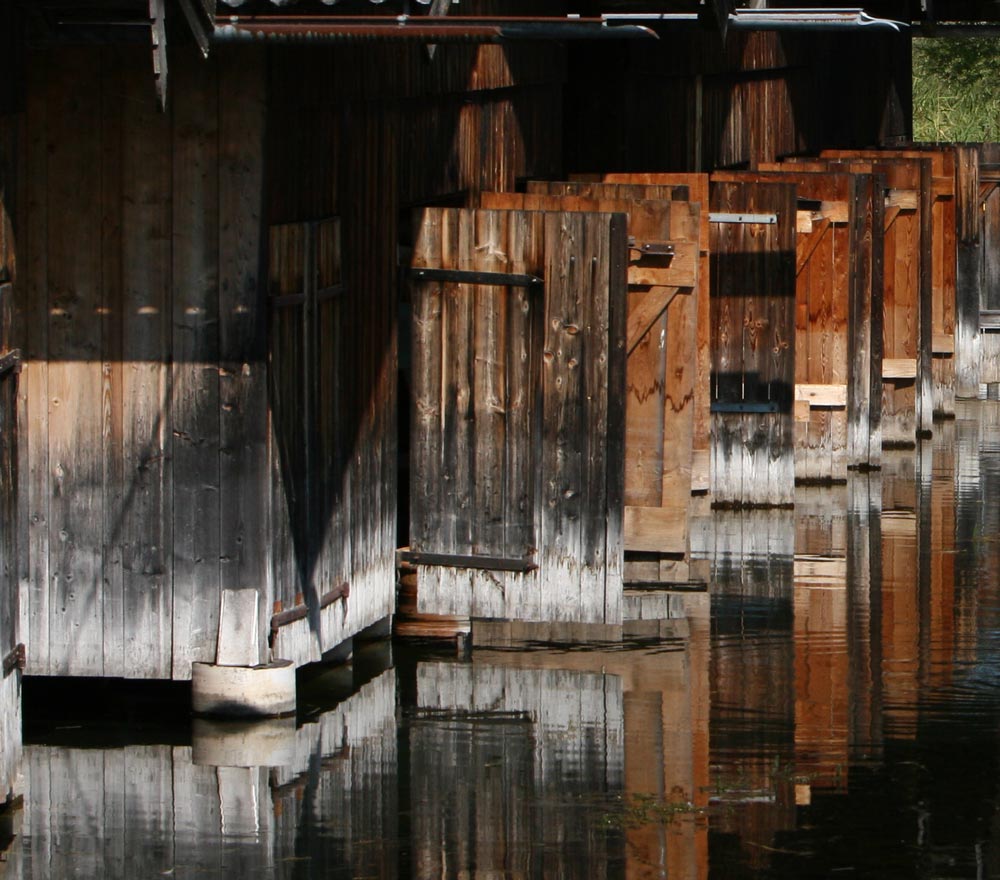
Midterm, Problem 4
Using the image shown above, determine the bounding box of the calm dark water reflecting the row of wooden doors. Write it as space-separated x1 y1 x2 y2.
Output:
9 403 1000 880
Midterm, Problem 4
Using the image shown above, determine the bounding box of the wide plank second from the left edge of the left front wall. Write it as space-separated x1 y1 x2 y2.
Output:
47 49 104 675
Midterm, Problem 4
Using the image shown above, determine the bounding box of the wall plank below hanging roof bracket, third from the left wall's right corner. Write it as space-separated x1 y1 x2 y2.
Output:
122 51 173 678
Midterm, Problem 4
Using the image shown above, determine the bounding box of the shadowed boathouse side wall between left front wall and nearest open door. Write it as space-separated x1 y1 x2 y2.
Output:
266 44 564 660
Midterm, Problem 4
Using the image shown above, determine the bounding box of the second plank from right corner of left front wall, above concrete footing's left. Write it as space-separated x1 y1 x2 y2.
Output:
174 50 220 678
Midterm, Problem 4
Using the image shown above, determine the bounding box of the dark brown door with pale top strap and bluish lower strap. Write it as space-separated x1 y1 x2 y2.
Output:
710 180 796 507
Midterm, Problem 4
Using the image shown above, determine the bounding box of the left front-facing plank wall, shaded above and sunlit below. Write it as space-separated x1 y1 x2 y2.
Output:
18 48 269 678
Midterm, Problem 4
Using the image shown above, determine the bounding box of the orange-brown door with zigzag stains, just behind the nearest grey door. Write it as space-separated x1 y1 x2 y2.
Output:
481 181 700 560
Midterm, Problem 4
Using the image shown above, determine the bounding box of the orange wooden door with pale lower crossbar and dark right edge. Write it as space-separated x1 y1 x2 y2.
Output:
713 163 882 482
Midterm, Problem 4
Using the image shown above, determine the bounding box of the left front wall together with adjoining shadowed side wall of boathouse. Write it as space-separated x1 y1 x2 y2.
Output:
15 32 564 678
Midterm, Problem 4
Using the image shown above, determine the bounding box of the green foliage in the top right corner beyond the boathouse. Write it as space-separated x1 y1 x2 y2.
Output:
913 37 1000 141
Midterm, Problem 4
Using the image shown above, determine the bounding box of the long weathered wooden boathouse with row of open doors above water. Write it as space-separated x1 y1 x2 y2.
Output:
0 0 1000 680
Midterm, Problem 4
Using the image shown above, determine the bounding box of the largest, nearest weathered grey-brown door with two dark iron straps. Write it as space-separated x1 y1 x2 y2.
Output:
406 209 626 625
